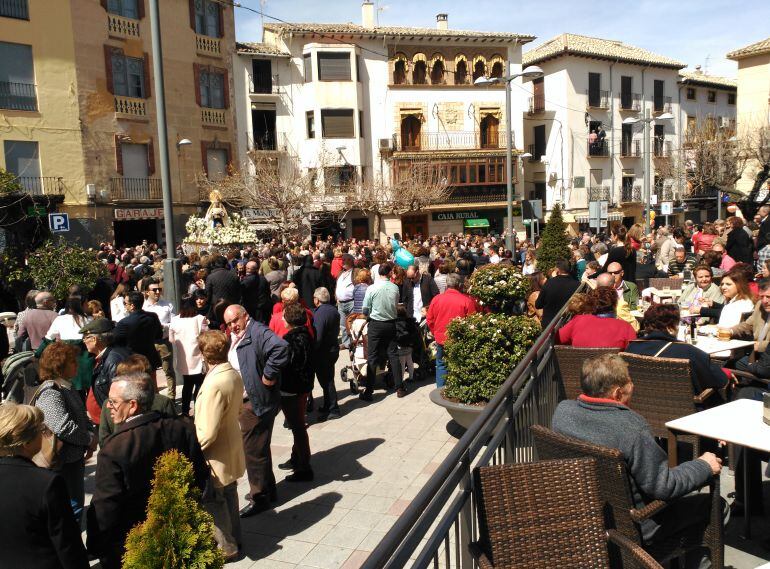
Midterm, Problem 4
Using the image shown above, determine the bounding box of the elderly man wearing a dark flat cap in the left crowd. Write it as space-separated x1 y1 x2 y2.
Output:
80 318 132 425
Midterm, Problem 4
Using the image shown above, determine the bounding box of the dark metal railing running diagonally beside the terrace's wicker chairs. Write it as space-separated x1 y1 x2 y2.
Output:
362 289 582 569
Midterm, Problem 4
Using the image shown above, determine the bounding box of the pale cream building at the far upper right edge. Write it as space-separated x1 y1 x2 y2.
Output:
727 38 770 195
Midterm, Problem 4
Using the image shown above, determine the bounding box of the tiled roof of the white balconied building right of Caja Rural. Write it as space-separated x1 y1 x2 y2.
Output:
522 34 687 69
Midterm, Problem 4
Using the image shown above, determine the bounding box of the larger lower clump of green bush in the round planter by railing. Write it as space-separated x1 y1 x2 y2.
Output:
444 313 541 405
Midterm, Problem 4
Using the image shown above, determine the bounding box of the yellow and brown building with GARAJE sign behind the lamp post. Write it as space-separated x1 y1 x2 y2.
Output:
0 0 237 245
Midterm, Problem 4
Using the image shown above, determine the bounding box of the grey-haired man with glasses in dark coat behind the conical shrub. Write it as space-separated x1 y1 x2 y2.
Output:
87 373 209 569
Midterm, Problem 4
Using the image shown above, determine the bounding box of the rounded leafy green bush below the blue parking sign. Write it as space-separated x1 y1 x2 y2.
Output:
29 240 108 299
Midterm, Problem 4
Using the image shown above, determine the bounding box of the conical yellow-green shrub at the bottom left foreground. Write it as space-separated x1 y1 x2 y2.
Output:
123 450 225 569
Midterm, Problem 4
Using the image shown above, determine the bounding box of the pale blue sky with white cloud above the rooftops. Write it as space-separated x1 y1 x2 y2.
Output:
235 0 770 77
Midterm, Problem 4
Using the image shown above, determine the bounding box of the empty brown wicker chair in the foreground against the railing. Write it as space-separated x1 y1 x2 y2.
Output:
469 458 660 569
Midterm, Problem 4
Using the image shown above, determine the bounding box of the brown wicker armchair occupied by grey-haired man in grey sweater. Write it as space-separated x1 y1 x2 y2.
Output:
532 425 724 569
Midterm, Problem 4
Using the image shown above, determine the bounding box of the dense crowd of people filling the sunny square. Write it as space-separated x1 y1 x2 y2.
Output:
0 208 770 569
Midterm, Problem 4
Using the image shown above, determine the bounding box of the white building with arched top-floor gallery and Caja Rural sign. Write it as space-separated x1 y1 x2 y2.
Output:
234 1 534 238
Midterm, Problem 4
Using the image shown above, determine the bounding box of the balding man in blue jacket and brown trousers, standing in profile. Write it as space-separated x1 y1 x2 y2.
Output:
224 304 288 518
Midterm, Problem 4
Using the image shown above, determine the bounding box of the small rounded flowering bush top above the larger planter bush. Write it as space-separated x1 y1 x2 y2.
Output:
468 264 530 314
